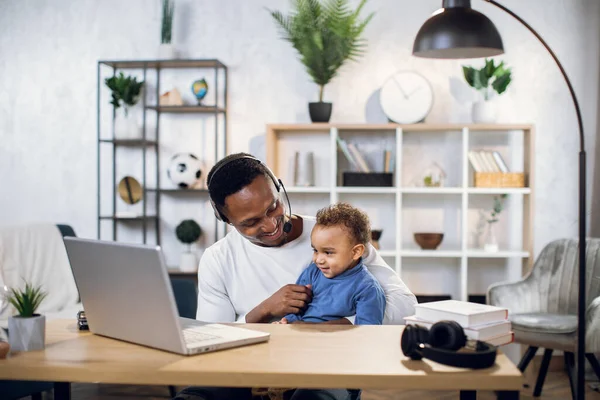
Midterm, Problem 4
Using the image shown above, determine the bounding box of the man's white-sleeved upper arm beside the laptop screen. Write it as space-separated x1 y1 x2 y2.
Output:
196 248 236 322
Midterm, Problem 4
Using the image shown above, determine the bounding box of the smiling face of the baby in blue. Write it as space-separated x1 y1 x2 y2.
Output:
311 225 360 278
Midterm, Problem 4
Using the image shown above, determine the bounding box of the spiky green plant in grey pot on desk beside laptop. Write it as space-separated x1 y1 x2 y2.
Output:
8 283 47 351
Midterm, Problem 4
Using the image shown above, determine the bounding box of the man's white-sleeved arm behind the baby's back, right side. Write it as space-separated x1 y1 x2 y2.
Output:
363 244 417 325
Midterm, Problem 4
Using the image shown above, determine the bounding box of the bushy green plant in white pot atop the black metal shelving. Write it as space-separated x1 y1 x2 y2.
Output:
104 72 144 139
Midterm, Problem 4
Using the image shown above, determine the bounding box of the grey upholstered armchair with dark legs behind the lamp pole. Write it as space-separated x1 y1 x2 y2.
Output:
487 239 600 397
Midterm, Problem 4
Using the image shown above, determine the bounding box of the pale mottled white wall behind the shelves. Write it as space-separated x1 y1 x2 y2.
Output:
0 0 600 262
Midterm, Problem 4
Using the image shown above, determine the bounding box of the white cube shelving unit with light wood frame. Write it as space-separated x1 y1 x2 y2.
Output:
266 124 535 300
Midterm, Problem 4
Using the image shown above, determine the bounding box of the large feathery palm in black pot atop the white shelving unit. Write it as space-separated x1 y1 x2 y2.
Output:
269 0 373 122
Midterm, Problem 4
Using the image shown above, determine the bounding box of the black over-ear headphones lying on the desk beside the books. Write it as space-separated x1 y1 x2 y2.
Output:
401 321 496 369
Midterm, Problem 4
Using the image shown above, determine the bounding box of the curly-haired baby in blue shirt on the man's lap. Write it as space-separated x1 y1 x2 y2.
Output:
279 203 385 325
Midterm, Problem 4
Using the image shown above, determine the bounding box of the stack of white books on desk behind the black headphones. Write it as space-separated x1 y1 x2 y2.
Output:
404 300 514 346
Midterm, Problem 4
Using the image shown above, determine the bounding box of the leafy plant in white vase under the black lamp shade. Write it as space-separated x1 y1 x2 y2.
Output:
463 58 511 123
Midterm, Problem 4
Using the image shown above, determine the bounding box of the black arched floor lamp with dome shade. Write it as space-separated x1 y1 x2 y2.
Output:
413 0 586 399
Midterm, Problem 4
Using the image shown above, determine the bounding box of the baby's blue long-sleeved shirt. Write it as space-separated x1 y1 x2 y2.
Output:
285 262 385 325
